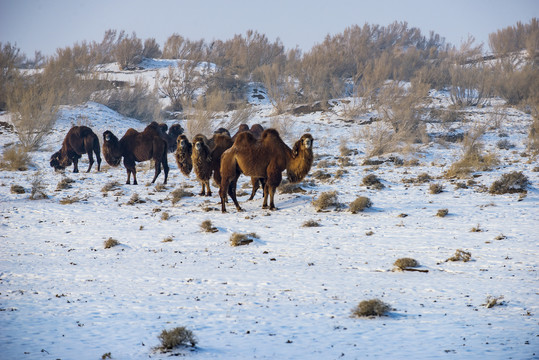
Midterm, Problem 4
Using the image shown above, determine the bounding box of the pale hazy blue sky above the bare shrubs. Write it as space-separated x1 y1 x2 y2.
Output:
0 0 539 58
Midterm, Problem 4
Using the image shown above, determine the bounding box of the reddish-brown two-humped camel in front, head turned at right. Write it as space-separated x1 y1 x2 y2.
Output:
219 129 313 212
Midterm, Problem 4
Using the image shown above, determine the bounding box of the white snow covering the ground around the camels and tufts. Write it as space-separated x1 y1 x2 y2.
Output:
0 86 539 359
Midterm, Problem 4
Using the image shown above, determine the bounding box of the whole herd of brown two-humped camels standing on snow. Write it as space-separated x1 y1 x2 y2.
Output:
50 121 313 212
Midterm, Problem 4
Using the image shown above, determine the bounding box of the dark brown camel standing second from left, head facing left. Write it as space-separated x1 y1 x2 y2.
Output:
103 122 169 185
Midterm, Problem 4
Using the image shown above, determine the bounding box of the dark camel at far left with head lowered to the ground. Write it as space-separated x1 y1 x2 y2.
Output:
50 126 101 173
